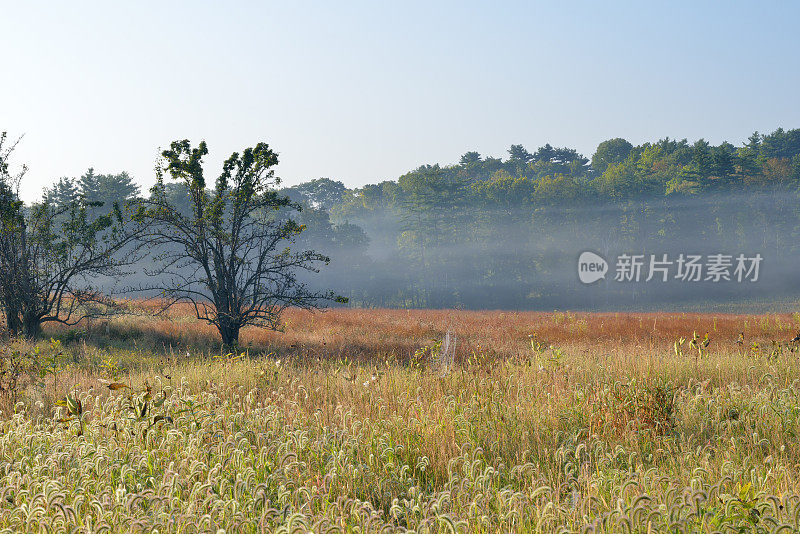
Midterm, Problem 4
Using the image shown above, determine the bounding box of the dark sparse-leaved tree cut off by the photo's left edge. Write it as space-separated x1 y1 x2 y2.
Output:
0 133 137 338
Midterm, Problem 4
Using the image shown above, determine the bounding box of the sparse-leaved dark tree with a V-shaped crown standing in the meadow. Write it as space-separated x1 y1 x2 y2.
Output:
137 140 346 348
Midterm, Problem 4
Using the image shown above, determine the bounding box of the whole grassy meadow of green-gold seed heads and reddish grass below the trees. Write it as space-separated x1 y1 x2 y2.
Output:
0 308 800 533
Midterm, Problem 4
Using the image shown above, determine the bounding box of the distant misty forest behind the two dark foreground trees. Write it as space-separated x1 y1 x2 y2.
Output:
32 128 800 310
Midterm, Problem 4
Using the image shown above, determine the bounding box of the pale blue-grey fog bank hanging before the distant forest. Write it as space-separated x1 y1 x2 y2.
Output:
290 191 800 311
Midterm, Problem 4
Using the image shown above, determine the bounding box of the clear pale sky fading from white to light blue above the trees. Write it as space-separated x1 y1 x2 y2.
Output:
0 0 800 201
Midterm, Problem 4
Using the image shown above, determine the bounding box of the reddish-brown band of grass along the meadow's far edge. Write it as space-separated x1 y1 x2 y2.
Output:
46 303 800 359
